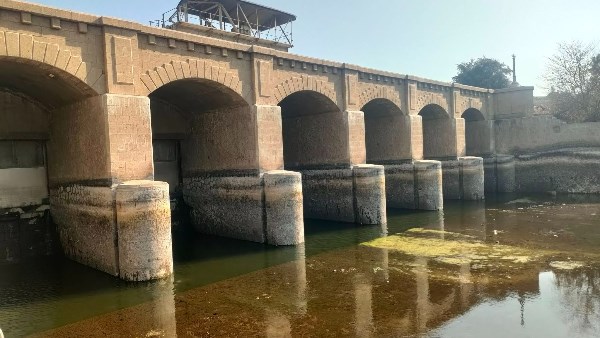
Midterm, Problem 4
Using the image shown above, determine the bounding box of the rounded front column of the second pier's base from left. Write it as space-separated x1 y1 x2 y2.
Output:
263 170 304 245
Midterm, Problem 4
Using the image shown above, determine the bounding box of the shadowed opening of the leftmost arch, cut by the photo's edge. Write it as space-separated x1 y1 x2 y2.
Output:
0 57 95 263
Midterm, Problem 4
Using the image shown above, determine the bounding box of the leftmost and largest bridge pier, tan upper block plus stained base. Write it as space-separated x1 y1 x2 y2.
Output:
48 94 173 281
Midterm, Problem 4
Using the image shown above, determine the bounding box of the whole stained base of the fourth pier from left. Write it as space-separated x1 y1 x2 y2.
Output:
385 161 444 210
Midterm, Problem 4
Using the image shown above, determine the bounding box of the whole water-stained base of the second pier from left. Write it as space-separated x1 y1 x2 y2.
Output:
183 171 304 245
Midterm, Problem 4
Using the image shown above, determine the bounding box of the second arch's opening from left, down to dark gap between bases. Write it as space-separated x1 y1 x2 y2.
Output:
149 79 257 232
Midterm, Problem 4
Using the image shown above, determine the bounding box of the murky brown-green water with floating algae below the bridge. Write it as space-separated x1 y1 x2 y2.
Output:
0 196 600 337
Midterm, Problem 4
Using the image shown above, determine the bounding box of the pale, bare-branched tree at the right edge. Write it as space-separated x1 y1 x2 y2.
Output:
544 41 600 122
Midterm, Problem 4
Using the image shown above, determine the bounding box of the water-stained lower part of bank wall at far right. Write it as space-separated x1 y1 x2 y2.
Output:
515 148 600 194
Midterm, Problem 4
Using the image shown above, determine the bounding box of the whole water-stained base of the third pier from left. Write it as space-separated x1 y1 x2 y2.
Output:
302 164 387 224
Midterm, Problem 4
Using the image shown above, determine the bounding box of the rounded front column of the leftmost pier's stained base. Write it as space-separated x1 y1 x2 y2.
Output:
115 181 173 281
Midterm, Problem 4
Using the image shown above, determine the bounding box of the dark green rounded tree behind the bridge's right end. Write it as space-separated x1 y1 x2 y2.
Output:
452 56 512 89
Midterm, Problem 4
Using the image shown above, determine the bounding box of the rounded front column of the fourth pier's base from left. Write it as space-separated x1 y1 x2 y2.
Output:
414 161 444 210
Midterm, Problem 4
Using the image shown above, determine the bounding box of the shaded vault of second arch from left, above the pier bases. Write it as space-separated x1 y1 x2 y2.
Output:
148 77 258 194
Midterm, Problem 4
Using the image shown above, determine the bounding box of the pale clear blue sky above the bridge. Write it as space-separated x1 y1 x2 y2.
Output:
30 0 600 95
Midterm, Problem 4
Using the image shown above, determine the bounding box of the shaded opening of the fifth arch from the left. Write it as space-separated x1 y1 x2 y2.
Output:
419 104 457 159
